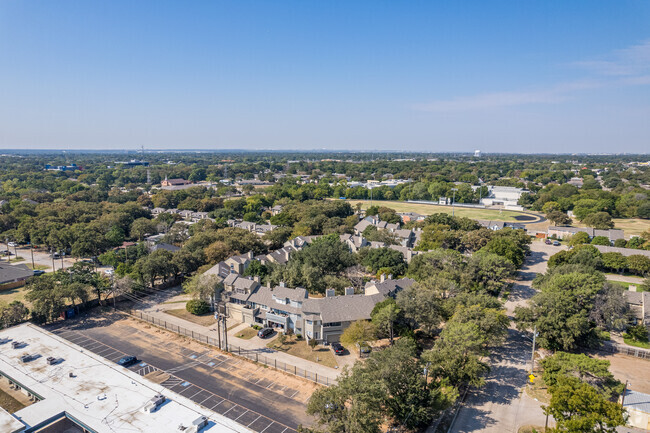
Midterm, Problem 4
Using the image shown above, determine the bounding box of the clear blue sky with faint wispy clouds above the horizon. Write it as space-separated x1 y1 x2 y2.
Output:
0 0 650 153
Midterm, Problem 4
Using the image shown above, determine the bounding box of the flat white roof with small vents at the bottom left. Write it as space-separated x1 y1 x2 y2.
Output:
0 324 252 433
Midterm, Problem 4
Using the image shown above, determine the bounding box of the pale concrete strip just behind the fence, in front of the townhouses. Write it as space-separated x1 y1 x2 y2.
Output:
136 304 341 382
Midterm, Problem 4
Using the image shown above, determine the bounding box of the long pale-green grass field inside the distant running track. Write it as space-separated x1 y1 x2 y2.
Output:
347 200 526 222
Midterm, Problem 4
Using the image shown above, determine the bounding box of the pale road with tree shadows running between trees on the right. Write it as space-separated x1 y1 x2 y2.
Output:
450 241 559 433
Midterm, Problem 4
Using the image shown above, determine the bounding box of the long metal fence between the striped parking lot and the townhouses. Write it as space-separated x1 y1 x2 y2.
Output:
127 310 336 386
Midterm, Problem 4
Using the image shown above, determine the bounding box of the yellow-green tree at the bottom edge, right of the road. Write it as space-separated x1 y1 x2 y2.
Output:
544 377 625 433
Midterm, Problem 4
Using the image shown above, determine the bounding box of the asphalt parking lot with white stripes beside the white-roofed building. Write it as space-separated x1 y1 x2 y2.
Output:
48 315 316 433
